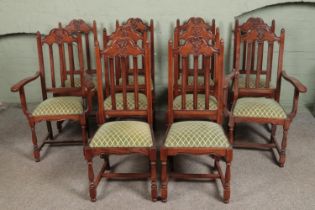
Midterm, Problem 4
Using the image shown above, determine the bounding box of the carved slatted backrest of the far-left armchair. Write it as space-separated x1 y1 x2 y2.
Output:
37 28 85 99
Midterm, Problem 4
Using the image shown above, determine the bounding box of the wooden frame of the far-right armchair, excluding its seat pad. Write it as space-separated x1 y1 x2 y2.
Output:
229 18 307 167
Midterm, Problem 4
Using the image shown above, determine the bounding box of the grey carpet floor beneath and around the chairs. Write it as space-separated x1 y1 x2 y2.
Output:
0 105 315 210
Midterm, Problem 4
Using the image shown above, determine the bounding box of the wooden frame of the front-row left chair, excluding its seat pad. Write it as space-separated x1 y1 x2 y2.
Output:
84 37 157 201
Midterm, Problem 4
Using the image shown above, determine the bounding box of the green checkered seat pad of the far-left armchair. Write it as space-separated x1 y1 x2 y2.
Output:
32 96 83 116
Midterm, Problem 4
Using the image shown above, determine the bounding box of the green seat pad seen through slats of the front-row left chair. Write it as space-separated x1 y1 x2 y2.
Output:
104 92 147 110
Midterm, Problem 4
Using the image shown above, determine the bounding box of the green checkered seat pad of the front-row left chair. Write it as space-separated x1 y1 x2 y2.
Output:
89 121 153 147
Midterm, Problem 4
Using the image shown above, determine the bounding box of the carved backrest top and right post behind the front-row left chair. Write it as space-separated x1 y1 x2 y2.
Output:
116 18 155 82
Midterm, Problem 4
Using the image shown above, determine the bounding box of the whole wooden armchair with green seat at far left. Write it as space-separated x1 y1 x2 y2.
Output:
11 28 94 161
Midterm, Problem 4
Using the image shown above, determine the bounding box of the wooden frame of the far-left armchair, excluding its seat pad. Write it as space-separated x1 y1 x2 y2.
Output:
11 28 94 162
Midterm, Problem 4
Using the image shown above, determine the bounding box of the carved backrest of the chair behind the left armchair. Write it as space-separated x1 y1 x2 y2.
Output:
59 19 97 74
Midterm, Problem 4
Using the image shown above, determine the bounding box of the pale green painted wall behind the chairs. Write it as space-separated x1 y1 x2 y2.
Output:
0 0 315 109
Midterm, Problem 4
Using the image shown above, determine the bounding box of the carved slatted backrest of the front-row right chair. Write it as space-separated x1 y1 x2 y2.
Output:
168 34 224 123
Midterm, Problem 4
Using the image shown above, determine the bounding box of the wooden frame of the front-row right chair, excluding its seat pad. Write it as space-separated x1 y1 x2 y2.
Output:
160 37 233 203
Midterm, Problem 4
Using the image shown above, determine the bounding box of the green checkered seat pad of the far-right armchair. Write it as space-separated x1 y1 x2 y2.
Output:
233 97 287 119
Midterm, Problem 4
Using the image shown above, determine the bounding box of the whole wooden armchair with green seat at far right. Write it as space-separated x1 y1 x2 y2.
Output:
229 18 306 167
